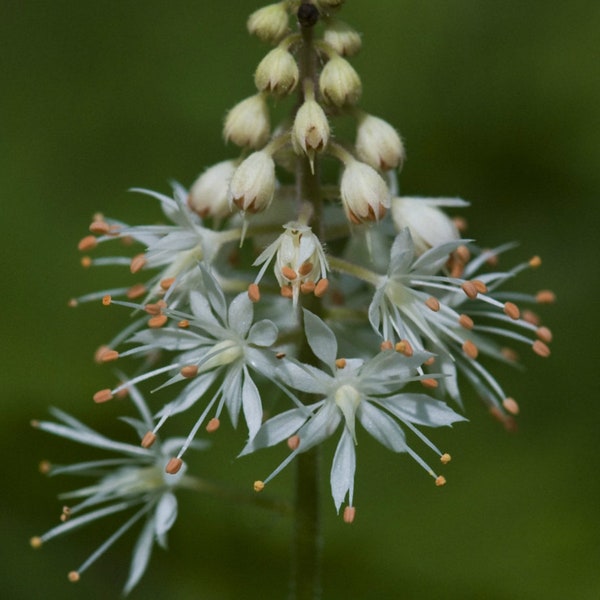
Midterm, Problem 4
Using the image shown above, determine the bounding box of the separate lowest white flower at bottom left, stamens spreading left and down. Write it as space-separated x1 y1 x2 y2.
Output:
31 387 206 594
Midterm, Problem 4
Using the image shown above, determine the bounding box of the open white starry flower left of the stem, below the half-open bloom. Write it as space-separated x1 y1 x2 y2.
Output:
94 266 278 459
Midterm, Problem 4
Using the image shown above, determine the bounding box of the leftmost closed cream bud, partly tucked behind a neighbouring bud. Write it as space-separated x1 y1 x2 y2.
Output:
188 160 237 219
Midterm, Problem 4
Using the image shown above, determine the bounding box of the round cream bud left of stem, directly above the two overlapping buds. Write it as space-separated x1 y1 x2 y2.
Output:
223 94 271 148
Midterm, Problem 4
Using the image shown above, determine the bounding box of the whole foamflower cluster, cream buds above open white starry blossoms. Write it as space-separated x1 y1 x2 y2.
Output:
33 0 553 591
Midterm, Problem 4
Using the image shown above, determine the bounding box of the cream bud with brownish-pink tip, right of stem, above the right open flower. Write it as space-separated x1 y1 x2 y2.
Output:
340 159 390 224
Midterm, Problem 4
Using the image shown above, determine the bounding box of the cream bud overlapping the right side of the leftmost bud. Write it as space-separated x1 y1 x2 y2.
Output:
229 150 275 213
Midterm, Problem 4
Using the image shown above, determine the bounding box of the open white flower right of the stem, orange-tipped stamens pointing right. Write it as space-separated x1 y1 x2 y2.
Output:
369 229 551 425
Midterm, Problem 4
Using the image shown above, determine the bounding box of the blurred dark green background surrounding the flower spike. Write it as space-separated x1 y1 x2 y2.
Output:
0 0 600 600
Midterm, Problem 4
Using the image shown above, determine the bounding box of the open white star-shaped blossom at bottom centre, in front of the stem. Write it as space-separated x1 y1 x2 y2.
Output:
242 310 465 521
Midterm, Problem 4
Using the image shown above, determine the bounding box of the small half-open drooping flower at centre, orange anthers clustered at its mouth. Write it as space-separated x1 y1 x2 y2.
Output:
248 222 328 306
